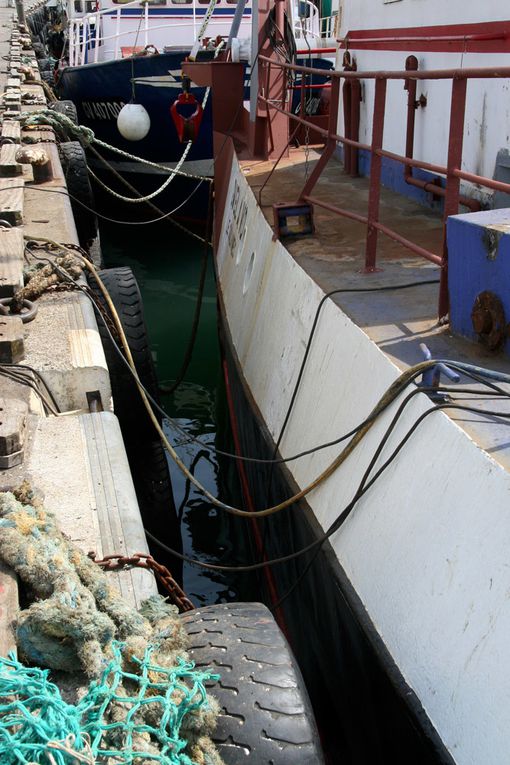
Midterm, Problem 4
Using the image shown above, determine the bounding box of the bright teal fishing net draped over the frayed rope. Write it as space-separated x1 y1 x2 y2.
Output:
0 641 218 765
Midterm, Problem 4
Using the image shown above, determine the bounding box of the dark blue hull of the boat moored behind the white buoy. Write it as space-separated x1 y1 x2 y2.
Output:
57 48 332 220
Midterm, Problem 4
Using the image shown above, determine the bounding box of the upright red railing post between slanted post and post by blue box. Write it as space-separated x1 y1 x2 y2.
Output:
364 77 387 274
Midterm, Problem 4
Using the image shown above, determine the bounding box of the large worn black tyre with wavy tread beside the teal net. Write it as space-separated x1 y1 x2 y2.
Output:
181 603 324 765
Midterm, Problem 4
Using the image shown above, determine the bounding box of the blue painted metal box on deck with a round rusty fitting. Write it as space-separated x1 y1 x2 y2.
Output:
447 209 510 353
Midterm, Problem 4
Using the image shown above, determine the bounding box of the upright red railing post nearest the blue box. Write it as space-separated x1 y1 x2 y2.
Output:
438 74 467 319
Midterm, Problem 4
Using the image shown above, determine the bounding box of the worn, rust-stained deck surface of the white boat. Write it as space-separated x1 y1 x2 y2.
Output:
241 148 510 469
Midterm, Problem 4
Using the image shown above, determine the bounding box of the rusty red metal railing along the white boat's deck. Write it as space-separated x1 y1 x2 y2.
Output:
259 56 510 317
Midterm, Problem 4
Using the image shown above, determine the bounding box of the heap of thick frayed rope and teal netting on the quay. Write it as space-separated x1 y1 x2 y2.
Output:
0 485 222 765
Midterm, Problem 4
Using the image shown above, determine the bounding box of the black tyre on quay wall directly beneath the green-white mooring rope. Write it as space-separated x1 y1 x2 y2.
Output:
59 141 97 248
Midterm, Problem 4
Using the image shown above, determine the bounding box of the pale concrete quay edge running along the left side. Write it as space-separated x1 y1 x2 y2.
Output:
0 0 156 655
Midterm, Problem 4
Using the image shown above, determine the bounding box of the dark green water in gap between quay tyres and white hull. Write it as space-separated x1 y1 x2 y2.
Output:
101 219 250 604
